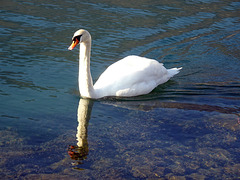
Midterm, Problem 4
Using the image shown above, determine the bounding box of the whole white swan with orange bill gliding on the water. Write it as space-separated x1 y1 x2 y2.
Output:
68 29 181 99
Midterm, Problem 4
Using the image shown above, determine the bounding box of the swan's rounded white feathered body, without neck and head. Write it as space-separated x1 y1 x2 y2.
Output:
94 56 176 97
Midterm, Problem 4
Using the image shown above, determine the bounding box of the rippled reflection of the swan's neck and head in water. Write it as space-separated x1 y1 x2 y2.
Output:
68 99 93 165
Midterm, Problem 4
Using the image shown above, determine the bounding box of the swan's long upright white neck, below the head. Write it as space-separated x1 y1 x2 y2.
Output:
78 40 94 98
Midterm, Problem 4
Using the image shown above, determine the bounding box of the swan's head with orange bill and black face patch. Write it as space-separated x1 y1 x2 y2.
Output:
68 29 91 50
